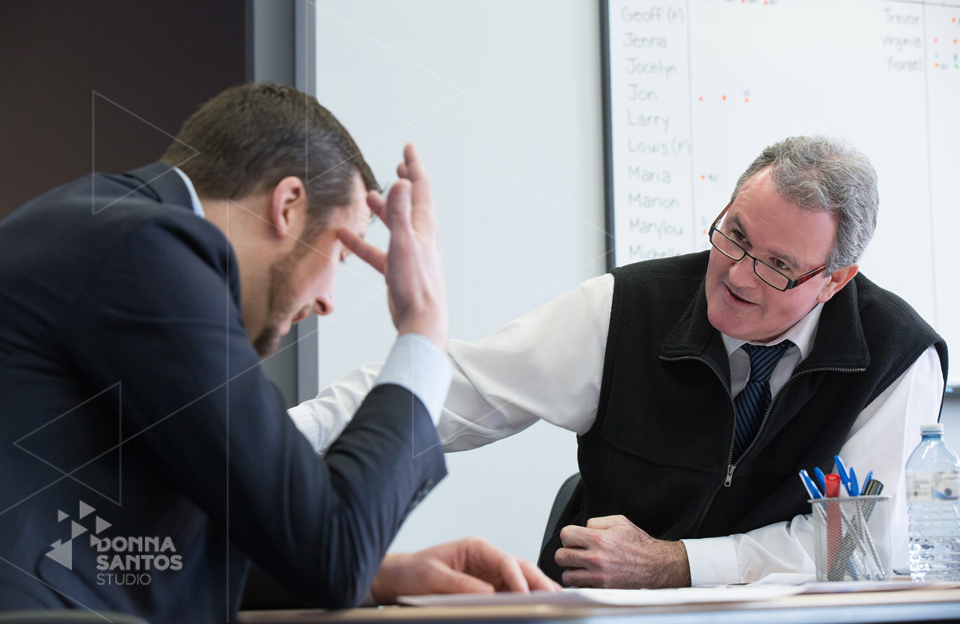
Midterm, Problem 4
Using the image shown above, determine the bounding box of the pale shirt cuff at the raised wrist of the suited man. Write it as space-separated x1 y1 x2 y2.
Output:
374 334 453 425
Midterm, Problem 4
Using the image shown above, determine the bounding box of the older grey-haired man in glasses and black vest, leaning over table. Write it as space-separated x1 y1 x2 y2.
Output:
291 137 947 587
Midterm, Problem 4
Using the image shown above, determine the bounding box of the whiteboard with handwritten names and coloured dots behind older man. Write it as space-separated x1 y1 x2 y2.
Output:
601 0 960 386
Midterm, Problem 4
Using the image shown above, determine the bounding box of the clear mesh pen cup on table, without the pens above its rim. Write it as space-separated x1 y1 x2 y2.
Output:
810 496 893 581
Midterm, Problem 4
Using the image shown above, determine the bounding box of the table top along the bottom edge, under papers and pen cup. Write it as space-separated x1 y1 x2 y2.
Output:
238 589 960 624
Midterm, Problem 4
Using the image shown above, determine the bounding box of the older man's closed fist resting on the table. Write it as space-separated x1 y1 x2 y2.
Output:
555 516 690 589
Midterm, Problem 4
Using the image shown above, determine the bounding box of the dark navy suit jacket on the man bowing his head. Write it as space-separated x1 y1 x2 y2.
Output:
0 163 446 624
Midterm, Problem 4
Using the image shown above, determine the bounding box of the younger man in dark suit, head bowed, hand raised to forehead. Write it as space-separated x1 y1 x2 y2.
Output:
0 84 552 623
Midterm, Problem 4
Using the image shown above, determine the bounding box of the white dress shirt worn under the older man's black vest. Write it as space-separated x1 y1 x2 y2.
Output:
289 274 943 586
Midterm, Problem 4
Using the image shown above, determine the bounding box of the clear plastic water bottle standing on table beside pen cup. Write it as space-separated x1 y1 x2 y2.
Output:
906 425 960 581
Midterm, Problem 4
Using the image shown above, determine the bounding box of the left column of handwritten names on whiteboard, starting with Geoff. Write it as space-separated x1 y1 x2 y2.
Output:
609 0 693 266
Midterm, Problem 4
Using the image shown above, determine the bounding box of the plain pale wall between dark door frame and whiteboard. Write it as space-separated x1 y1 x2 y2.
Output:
298 0 606 561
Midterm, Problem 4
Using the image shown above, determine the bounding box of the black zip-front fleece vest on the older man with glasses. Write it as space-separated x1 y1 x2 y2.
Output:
540 251 947 581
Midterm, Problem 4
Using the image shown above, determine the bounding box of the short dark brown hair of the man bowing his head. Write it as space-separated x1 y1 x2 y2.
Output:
162 82 380 232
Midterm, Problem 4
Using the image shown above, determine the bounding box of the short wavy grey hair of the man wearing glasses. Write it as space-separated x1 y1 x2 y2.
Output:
731 136 880 273
